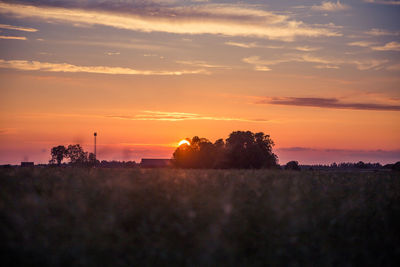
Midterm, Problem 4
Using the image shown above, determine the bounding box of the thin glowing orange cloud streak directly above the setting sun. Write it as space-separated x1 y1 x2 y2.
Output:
106 110 267 122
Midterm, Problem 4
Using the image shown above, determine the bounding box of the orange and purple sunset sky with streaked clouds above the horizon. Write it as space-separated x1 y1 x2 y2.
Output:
0 0 400 164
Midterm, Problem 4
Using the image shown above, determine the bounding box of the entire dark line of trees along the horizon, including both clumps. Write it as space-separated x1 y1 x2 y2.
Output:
44 131 400 171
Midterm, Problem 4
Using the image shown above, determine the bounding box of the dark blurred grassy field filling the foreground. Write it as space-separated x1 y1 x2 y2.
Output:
0 168 400 266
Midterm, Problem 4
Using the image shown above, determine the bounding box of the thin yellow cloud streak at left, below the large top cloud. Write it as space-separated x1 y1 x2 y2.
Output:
0 59 207 75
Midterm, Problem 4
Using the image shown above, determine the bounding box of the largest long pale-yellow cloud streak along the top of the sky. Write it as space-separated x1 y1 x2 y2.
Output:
0 1 341 41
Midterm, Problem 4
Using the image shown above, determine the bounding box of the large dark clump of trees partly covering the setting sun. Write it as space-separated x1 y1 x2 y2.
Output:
173 131 278 169
